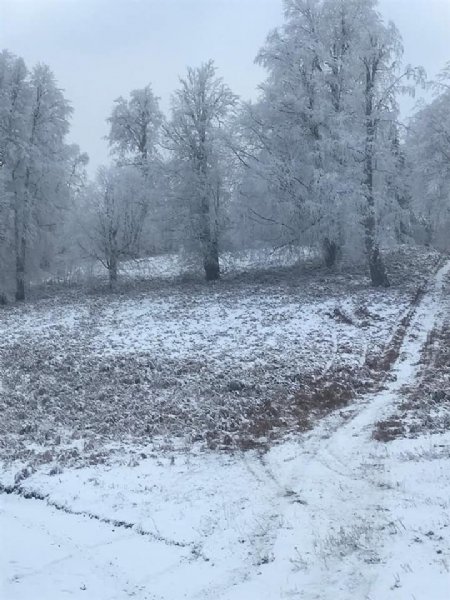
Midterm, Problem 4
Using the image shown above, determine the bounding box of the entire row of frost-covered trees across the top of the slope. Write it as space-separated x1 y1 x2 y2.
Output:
0 0 450 299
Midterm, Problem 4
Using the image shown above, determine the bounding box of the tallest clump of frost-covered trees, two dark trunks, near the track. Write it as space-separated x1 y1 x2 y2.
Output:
243 0 421 285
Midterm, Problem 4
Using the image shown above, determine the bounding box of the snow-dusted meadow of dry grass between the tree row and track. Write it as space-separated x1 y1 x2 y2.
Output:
0 246 437 462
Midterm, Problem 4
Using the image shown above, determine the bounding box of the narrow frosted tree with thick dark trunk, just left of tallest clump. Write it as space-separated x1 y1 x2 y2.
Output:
166 61 237 280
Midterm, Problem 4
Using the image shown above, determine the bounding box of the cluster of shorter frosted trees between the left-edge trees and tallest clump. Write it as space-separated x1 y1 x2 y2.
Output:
71 62 238 285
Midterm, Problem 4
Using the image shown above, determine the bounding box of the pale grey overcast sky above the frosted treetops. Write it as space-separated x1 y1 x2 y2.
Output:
0 0 450 172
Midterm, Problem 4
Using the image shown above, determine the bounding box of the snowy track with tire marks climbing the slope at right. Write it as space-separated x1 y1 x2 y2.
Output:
214 261 450 600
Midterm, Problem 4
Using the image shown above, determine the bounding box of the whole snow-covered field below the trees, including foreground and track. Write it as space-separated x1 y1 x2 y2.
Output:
0 247 450 600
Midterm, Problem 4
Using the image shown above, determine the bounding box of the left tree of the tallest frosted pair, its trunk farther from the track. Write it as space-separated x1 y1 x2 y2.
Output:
243 0 366 266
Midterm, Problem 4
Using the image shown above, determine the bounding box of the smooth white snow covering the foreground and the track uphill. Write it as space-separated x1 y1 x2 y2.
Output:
0 263 450 600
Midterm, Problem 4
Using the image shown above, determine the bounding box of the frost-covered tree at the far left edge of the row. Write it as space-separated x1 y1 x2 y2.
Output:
0 52 74 300
